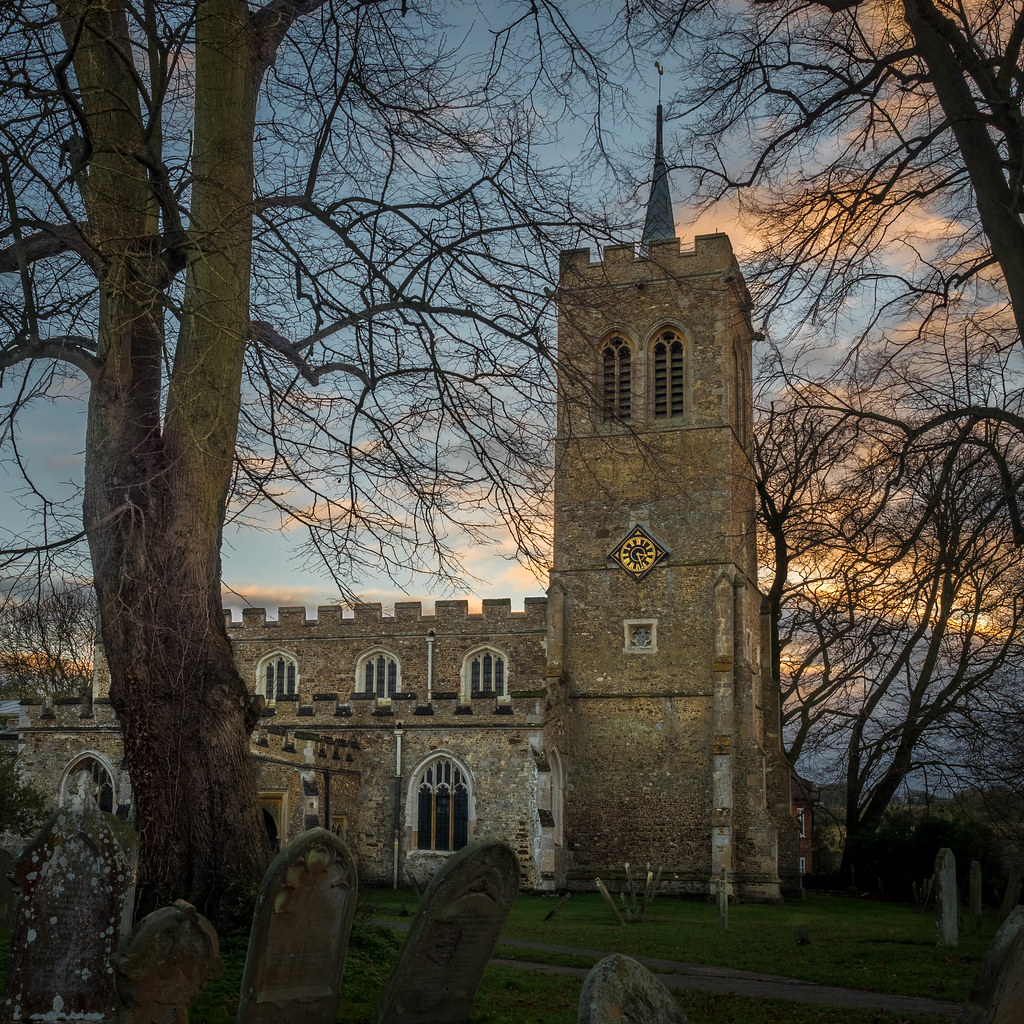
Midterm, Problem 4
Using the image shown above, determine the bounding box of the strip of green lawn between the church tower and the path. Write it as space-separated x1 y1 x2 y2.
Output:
362 889 995 1001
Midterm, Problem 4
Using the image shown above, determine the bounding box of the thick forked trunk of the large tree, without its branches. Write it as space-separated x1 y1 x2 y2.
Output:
59 0 267 925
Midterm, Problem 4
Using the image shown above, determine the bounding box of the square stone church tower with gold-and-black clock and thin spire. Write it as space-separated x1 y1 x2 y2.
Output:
545 105 788 900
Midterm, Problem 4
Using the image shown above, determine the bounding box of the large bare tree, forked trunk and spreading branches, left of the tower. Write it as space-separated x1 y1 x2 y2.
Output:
0 0 630 920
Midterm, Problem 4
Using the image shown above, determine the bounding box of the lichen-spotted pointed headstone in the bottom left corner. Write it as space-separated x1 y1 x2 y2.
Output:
2 772 138 1021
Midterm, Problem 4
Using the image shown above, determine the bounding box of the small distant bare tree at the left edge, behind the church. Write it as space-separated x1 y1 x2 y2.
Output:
0 585 96 700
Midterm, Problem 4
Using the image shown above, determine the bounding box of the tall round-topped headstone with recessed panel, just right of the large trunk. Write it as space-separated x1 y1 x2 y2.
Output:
238 828 358 1024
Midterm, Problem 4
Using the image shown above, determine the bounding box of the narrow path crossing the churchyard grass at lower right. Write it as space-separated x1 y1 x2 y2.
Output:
493 939 959 1017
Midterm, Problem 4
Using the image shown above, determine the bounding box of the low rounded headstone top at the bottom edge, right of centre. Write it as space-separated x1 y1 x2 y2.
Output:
577 953 687 1024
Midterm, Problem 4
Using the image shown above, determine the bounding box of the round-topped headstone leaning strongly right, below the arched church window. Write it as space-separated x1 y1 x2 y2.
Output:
375 842 519 1024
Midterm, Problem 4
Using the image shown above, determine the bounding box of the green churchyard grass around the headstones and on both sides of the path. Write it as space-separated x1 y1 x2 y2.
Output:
0 890 995 1024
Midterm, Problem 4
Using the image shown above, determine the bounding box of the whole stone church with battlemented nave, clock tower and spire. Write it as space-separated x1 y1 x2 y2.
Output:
5 110 799 900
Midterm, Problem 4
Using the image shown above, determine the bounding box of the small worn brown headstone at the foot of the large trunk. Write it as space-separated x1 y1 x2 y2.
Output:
111 900 224 1024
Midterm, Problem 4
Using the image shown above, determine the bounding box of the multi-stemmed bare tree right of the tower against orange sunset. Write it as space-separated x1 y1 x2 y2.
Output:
758 343 1024 871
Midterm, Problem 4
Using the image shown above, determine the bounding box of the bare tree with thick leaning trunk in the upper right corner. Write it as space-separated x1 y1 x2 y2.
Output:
633 0 1024 352
